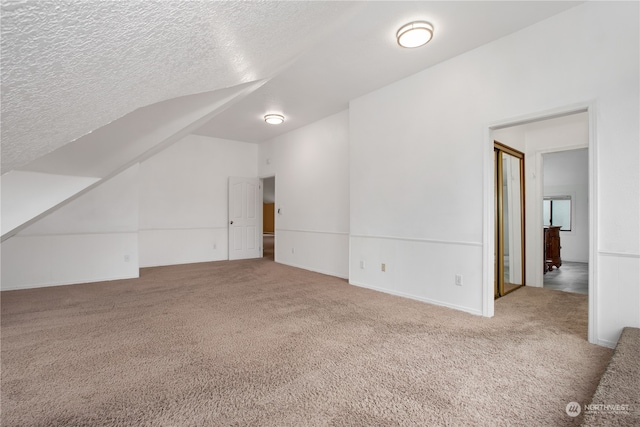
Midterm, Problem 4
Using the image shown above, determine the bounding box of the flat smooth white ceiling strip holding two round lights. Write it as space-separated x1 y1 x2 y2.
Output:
195 1 577 142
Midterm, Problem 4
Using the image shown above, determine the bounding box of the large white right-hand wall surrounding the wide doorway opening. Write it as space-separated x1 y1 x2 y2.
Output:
349 2 640 345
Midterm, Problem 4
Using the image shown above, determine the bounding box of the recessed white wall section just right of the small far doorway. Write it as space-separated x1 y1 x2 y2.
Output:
259 111 349 278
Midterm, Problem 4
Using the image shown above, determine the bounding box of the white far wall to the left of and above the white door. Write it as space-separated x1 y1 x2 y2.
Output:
140 135 258 267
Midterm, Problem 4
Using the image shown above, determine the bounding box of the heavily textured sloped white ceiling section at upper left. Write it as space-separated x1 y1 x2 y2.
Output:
1 0 357 173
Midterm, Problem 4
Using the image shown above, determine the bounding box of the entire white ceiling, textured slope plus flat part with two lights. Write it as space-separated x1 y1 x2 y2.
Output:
1 0 580 173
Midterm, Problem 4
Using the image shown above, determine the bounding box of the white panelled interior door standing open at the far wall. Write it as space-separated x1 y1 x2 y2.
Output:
229 177 262 260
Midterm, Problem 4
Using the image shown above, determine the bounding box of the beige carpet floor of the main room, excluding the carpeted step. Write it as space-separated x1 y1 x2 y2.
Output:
1 260 612 426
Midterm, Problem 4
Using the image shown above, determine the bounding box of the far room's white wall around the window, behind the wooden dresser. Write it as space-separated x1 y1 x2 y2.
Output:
543 149 589 262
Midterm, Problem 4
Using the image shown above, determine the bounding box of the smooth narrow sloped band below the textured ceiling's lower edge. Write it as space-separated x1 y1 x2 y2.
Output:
0 80 265 241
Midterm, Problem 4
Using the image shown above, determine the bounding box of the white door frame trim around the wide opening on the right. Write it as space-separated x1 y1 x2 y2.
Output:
482 101 599 344
